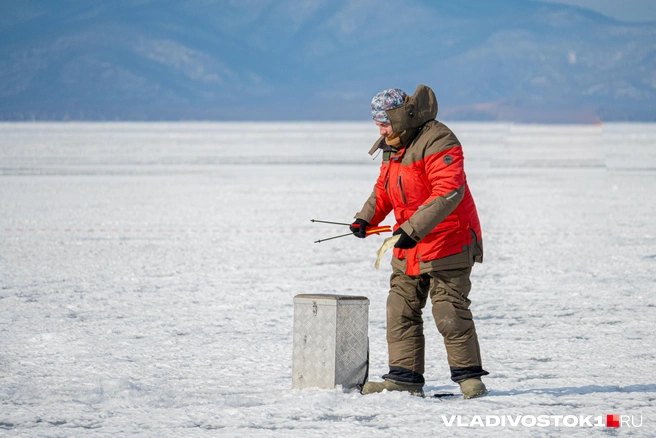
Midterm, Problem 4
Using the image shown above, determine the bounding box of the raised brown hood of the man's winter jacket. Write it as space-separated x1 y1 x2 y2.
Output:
386 85 437 132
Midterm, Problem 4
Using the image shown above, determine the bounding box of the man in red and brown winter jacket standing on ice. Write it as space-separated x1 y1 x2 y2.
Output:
351 85 489 398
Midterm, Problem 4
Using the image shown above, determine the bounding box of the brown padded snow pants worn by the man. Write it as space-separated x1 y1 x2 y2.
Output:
384 268 488 383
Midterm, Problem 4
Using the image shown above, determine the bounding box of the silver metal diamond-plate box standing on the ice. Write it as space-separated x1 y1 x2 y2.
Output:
292 295 369 389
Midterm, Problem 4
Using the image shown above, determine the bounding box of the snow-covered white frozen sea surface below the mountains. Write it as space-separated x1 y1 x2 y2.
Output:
0 123 656 437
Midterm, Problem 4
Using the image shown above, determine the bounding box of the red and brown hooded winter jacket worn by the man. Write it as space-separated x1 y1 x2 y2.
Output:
355 85 483 275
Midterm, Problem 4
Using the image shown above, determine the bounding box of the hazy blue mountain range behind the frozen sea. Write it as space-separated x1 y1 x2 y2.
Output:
0 0 656 122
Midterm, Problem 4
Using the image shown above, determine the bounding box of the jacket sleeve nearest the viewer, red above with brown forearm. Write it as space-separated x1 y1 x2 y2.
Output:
401 138 466 242
